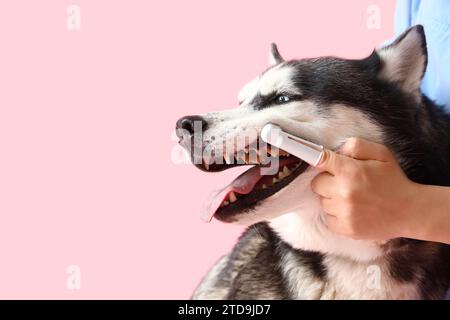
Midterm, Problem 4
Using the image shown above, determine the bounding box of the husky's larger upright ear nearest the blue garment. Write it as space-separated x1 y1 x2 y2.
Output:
377 25 427 98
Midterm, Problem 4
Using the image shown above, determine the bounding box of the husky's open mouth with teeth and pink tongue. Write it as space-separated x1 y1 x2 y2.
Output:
200 146 308 222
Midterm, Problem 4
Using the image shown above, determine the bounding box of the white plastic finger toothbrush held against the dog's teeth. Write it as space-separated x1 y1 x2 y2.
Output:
261 123 323 167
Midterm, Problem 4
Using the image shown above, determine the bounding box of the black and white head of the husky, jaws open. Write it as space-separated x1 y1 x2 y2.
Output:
177 26 427 259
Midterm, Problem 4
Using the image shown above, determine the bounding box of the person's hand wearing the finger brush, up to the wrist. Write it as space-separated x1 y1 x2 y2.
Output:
311 138 419 240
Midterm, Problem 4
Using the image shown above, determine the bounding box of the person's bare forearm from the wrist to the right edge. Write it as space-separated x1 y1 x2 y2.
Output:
402 185 450 244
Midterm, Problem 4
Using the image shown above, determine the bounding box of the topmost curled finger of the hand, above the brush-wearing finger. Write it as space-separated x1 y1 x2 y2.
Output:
338 138 394 161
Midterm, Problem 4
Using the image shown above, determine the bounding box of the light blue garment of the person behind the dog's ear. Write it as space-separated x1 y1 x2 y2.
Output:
395 0 450 112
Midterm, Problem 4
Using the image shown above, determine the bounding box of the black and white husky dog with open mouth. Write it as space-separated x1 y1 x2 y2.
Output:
177 26 450 299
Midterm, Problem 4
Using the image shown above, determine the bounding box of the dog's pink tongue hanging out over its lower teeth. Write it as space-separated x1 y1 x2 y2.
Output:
201 167 262 222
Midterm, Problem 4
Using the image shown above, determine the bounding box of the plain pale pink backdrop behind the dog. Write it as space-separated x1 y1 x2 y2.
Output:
0 0 395 299
